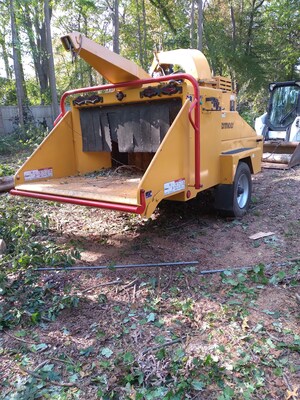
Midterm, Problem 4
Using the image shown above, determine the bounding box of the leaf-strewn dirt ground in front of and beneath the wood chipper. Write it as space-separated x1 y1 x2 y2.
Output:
0 167 300 400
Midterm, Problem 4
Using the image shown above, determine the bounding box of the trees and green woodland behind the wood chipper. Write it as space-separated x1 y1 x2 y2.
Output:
0 0 300 130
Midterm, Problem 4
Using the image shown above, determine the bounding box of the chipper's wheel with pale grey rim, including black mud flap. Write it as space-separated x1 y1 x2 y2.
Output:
215 161 252 218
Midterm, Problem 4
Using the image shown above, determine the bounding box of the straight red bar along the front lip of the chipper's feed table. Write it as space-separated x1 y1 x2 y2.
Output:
10 189 146 214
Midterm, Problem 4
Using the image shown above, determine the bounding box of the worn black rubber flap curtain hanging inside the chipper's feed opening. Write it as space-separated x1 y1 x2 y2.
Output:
80 99 181 153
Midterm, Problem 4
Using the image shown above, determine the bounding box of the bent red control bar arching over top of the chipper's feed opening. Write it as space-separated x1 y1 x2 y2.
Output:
54 74 201 189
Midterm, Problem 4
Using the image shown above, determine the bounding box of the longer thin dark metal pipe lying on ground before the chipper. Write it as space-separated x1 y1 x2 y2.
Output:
34 261 199 272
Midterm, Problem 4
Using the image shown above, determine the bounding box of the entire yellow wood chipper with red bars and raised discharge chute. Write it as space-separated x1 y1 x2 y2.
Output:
11 32 263 218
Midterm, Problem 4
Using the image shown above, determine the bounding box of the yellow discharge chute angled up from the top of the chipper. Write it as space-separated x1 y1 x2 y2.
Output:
61 32 150 83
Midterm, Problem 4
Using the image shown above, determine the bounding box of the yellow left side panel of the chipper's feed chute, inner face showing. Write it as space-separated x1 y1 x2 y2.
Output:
15 112 76 188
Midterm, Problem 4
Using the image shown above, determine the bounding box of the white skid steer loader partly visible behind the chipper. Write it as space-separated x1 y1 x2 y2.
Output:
255 81 300 169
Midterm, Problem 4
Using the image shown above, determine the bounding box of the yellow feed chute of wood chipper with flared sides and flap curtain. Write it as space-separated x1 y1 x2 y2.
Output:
11 74 199 217
